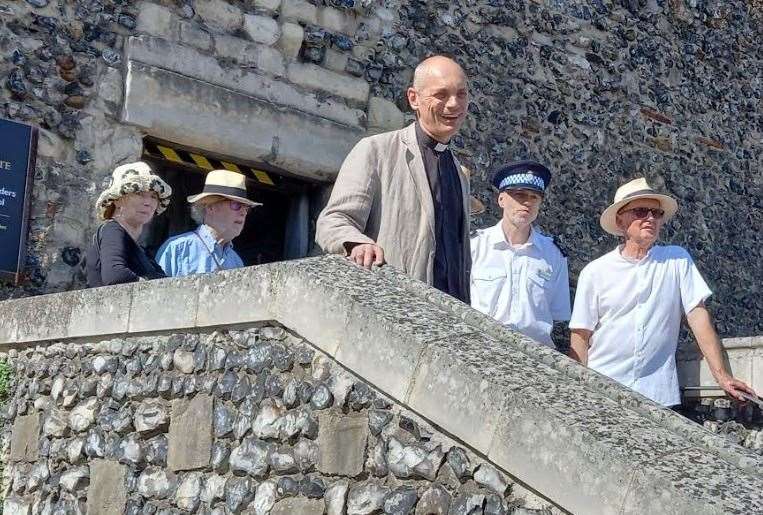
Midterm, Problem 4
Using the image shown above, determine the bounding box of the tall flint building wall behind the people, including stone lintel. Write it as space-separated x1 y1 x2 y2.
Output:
0 0 763 346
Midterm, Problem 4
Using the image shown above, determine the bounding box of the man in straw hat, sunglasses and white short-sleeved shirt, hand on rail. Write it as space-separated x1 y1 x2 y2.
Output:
570 178 755 406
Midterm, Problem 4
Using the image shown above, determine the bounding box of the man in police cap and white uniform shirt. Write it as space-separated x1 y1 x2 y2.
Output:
470 161 570 347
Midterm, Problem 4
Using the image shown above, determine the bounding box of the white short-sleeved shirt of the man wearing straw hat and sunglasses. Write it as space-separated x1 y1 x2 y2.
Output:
570 245 712 406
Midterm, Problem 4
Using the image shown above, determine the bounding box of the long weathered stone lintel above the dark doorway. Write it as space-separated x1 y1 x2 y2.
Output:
122 62 364 181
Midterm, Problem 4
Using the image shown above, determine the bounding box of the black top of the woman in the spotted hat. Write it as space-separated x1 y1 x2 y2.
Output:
86 220 167 288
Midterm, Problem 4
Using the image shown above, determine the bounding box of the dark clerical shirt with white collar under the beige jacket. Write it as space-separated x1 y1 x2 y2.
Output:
416 123 469 304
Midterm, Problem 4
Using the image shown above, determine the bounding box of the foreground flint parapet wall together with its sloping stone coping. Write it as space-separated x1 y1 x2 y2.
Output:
0 257 763 514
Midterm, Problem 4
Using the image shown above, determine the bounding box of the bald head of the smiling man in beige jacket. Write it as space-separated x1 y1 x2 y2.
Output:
408 55 469 143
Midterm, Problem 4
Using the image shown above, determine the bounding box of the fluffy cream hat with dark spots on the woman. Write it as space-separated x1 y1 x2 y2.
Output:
95 161 172 220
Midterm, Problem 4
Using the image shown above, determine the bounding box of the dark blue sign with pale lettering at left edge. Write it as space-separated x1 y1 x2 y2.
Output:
0 118 37 284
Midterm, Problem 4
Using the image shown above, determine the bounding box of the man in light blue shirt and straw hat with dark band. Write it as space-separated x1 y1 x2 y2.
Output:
157 170 262 277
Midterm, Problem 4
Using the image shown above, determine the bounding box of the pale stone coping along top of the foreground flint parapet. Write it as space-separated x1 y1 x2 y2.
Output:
0 256 763 514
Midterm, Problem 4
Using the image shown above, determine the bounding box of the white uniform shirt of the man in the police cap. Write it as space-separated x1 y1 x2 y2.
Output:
470 222 570 347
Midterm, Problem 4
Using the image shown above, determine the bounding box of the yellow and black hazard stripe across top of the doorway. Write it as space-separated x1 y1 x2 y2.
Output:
143 140 304 191
